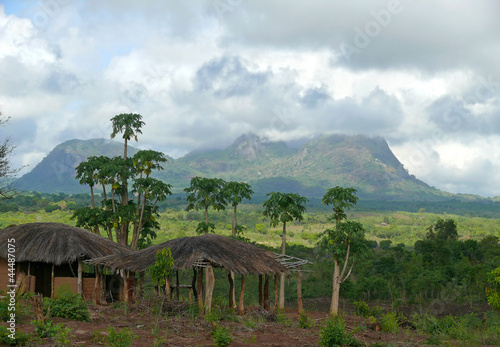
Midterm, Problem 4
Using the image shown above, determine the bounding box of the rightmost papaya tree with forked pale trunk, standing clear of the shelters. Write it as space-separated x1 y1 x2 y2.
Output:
318 186 368 315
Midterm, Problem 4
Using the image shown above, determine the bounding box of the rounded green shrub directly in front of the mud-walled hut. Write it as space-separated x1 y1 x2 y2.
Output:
43 290 90 322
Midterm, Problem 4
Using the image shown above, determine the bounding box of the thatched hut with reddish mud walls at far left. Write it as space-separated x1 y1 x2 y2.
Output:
0 223 131 301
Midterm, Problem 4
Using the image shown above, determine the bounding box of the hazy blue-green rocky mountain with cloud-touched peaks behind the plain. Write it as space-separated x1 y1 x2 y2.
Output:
17 134 451 200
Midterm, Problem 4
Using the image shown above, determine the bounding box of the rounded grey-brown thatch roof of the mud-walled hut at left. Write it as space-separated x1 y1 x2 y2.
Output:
0 223 131 265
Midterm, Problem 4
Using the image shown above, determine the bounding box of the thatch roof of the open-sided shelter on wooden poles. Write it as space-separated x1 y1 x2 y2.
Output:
88 234 288 275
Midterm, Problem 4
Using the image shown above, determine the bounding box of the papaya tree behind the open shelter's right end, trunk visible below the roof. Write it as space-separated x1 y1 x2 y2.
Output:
262 192 308 308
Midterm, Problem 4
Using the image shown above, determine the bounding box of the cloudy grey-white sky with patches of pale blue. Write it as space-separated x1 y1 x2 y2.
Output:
0 0 500 197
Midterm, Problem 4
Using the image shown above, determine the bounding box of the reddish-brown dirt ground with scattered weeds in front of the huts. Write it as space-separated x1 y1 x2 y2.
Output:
1 301 498 347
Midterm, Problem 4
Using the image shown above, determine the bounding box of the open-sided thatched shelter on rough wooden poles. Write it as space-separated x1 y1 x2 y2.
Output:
88 234 289 310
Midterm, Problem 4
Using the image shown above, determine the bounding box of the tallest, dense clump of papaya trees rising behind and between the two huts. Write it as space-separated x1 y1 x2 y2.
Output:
72 114 172 250
